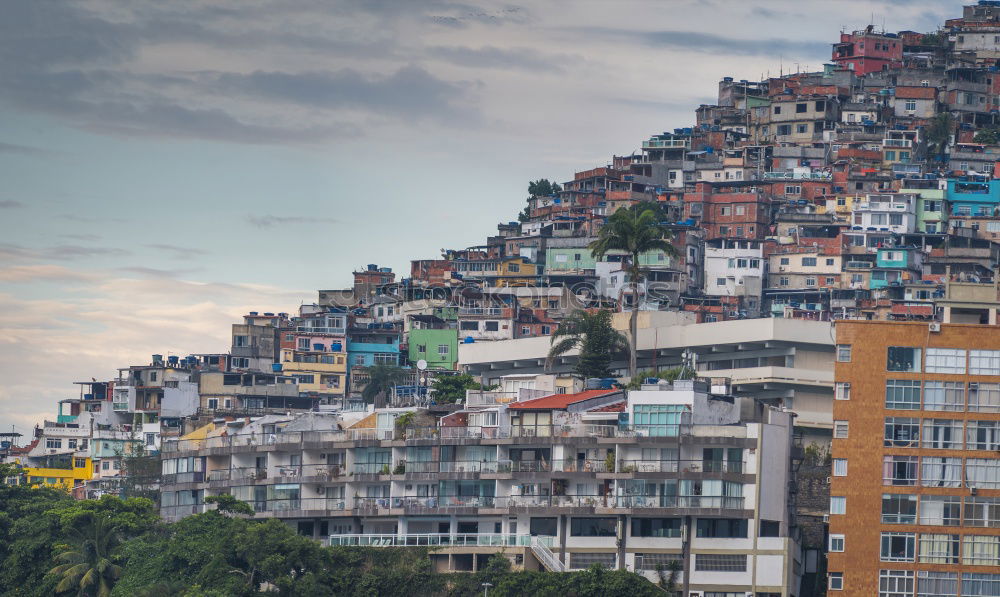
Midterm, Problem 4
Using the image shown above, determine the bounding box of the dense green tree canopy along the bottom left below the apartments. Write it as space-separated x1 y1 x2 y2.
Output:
0 465 663 597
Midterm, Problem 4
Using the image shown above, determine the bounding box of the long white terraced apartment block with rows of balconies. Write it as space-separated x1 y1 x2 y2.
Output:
161 380 801 597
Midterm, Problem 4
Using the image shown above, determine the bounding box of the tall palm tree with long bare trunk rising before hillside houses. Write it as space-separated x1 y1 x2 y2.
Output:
588 201 677 377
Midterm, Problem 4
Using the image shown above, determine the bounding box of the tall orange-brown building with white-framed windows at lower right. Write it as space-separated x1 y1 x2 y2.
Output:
828 321 1000 597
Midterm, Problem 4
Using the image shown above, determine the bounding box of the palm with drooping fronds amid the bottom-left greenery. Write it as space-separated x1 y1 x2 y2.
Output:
49 518 122 597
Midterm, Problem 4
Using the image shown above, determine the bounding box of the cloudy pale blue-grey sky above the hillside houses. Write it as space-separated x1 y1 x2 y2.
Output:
0 0 962 434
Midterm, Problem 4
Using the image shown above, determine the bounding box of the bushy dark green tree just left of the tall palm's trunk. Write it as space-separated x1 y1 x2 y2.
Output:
546 310 628 379
